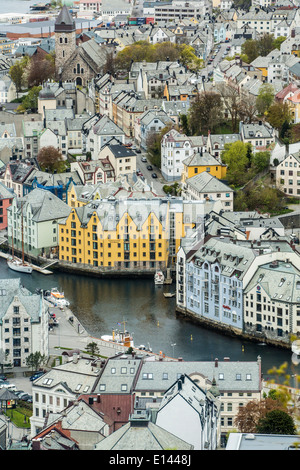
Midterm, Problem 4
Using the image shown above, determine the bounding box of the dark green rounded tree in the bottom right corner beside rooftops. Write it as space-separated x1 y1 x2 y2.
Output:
256 410 296 435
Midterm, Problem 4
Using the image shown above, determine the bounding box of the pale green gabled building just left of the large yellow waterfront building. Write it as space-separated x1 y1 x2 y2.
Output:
7 188 71 256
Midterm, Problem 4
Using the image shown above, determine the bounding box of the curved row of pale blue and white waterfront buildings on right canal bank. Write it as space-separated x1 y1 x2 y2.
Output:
176 236 300 344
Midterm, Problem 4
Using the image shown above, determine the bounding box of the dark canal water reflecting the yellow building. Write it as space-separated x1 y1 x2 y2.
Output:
0 259 300 378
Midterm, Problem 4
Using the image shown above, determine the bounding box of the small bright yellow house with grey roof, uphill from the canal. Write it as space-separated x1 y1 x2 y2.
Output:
181 152 227 183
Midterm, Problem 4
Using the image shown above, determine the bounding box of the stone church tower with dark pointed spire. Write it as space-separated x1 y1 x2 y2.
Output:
54 5 76 80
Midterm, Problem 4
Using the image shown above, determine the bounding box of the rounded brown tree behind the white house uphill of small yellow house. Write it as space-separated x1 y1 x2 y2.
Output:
188 91 223 135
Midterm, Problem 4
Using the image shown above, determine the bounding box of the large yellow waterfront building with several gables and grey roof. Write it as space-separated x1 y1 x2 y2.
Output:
59 198 203 271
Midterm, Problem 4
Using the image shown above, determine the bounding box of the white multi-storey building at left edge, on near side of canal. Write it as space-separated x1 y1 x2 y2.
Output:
0 279 49 367
